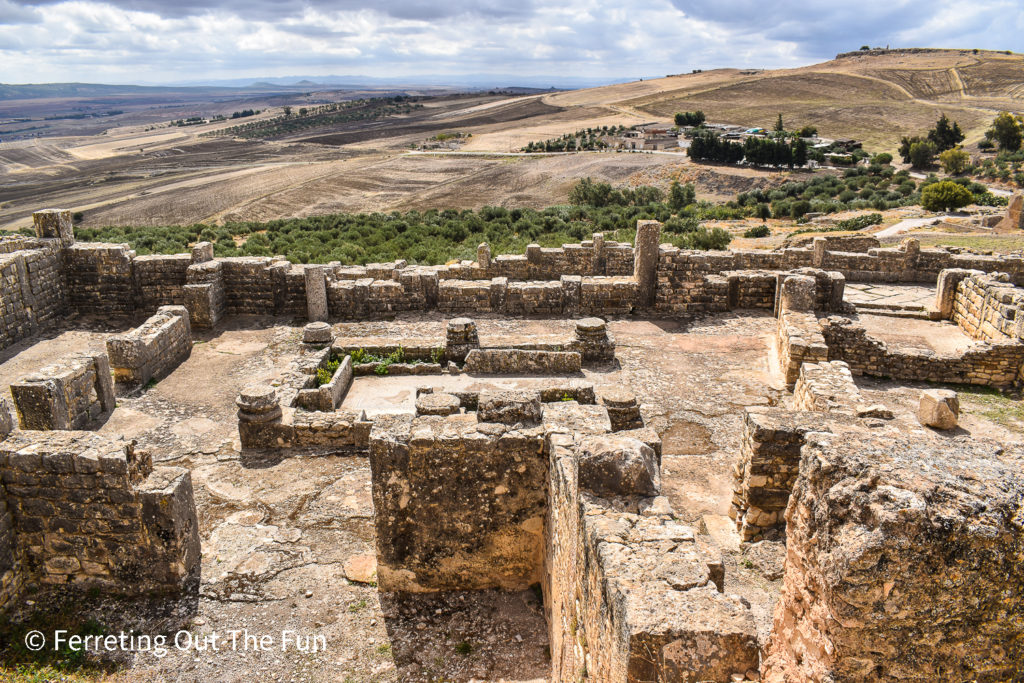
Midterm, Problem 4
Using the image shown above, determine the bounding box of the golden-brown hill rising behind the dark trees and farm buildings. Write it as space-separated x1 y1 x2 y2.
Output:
545 49 1024 150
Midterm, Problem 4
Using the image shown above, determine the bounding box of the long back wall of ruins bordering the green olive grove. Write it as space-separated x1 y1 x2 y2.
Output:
6 211 1024 358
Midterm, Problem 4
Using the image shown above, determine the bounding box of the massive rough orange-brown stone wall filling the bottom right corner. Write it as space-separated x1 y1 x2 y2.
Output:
761 434 1024 683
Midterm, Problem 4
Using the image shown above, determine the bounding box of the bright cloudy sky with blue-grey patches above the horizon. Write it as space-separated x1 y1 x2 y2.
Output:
0 0 1024 83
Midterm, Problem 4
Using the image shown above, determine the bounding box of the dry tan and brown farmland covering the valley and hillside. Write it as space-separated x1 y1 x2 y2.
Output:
0 50 1024 229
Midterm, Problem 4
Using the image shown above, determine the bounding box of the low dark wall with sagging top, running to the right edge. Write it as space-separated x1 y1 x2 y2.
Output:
819 316 1024 387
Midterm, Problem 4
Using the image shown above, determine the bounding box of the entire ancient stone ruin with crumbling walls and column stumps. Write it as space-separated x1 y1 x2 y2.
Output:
0 211 1024 683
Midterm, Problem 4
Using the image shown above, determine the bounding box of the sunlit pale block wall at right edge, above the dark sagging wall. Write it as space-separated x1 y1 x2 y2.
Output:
949 272 1024 341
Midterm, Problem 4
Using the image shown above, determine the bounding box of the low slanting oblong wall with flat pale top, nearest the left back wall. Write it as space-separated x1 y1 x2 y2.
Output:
106 306 193 391
